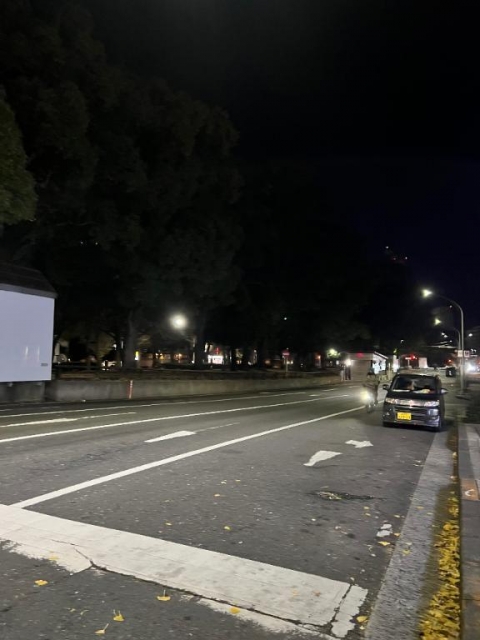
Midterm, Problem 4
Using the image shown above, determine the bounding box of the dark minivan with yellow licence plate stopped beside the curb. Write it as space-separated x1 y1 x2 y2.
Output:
383 373 447 431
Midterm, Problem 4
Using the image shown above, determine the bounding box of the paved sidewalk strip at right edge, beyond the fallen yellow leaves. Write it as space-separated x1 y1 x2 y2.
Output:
458 424 480 640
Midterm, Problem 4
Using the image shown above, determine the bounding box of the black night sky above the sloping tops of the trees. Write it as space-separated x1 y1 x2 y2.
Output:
85 0 480 326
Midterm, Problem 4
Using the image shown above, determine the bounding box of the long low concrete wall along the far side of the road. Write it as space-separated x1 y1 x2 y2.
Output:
46 375 340 402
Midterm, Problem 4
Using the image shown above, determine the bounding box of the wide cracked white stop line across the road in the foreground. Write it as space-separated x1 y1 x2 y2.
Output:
0 505 368 637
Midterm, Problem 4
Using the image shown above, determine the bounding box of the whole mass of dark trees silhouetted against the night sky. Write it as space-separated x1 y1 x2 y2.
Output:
0 0 428 367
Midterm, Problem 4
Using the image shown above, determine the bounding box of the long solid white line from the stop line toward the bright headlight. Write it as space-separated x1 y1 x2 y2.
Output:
12 405 365 508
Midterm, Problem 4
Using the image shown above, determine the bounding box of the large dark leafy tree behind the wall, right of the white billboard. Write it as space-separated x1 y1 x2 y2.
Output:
0 1 241 366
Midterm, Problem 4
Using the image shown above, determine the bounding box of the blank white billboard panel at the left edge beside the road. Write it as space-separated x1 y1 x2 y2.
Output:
0 290 55 382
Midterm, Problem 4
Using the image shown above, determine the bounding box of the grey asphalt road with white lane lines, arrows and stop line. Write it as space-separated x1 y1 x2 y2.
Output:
0 383 460 640
